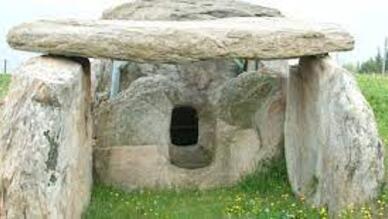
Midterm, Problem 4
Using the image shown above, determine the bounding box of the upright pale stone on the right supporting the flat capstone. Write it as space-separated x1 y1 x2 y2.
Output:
285 58 384 211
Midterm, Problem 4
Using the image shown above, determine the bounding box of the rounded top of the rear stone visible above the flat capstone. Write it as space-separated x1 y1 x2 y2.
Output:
103 0 282 21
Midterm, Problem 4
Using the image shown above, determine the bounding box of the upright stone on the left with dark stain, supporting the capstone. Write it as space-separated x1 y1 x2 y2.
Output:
0 57 92 219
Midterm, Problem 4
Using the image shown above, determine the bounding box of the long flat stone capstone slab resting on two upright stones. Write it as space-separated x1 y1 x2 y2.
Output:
8 17 354 62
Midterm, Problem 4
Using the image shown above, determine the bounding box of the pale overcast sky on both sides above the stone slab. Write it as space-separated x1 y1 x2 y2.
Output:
0 0 388 68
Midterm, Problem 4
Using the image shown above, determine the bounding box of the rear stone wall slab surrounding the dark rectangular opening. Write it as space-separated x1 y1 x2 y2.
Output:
94 60 285 189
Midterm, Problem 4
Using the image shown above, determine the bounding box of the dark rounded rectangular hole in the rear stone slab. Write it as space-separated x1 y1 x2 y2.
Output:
170 106 198 146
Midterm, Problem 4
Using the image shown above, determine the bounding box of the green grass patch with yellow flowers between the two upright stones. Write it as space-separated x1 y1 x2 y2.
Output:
84 160 327 219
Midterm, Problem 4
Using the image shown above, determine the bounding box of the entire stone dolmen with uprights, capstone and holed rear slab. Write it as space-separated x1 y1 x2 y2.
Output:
0 0 384 219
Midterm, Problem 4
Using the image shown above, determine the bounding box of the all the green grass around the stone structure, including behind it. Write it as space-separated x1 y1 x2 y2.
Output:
0 75 388 219
